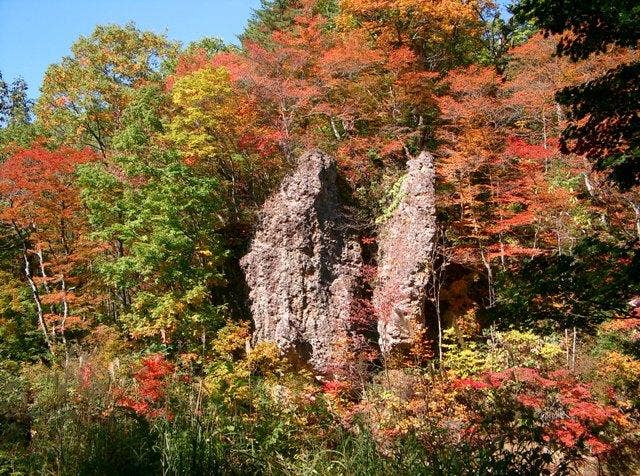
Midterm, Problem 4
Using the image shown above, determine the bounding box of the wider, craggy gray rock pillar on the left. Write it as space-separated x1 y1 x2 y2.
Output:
240 152 362 371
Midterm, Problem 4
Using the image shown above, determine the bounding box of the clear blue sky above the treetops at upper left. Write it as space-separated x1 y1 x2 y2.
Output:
0 0 260 98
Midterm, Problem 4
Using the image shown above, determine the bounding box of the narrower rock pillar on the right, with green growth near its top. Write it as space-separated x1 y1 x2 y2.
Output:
373 152 436 354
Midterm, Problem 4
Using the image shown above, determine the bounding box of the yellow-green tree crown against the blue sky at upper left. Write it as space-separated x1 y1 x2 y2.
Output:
36 24 176 157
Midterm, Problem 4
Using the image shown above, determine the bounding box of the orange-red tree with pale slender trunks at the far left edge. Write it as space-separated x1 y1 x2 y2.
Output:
0 146 95 351
